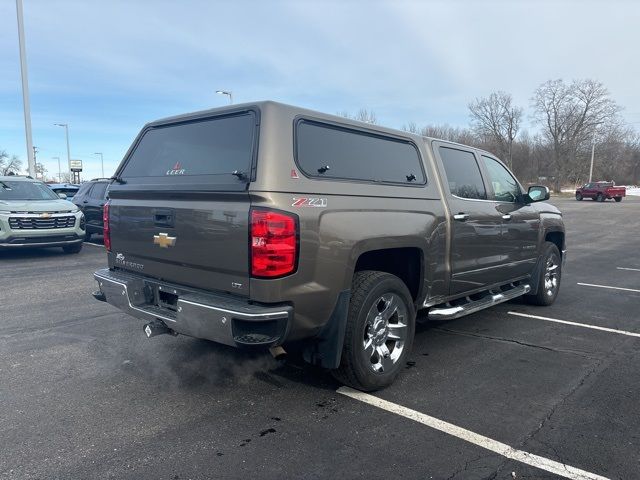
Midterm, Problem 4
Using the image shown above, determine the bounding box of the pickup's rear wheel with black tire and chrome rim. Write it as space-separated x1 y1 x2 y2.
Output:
332 271 416 392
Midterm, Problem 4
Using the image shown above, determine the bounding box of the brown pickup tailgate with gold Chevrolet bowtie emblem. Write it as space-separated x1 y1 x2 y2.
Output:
110 192 250 295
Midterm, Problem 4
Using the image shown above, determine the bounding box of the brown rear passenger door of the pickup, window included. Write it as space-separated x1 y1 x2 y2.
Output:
434 142 508 295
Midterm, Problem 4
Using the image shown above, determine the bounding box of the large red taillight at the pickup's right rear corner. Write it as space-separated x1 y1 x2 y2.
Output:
251 210 298 278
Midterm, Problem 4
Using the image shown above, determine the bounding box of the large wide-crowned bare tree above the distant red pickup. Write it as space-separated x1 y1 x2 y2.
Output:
532 80 620 191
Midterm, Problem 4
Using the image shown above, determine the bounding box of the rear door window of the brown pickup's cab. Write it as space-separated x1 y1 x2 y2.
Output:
440 147 487 200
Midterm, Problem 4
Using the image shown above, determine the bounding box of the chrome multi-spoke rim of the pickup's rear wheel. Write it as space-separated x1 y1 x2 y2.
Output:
362 293 408 373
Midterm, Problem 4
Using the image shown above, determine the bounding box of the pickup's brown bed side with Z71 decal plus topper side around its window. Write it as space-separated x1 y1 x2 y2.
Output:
250 105 446 340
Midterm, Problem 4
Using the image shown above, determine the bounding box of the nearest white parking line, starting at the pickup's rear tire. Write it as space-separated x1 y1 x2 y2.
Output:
337 387 607 480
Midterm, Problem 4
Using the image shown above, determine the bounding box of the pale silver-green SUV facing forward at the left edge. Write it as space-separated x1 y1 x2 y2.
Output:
0 175 85 253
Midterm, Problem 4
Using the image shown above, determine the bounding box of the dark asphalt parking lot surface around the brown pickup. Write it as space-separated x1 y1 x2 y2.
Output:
0 197 640 480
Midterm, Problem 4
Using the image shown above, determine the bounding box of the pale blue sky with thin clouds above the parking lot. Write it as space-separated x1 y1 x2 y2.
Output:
0 0 640 178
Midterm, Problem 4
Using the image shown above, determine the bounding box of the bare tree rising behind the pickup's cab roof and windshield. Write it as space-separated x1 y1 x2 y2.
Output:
468 92 522 168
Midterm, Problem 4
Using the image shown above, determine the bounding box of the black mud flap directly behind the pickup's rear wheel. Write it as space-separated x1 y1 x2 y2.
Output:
303 290 351 369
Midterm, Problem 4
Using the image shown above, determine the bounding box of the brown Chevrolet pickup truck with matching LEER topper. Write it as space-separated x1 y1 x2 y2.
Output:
94 102 566 390
